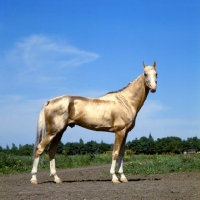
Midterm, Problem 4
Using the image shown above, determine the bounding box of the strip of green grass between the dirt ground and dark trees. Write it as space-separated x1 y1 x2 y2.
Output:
0 153 200 175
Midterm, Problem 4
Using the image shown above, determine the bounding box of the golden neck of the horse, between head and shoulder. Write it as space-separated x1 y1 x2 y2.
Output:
119 75 149 112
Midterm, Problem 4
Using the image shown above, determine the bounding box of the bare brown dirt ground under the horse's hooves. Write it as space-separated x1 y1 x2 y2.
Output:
0 165 200 200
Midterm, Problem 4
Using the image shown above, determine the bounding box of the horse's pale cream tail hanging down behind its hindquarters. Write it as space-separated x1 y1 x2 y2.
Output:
33 104 46 155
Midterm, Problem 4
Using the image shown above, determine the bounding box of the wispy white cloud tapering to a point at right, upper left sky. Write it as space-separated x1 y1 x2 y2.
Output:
8 35 99 69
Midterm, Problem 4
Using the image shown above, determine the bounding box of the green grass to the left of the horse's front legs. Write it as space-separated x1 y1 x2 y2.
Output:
0 153 111 174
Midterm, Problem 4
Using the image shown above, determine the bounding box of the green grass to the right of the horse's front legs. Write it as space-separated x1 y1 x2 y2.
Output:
124 154 200 175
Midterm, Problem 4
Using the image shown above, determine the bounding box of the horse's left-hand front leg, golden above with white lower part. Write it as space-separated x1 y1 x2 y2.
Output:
110 130 126 183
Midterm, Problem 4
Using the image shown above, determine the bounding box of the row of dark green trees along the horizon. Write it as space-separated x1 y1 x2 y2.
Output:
0 134 200 156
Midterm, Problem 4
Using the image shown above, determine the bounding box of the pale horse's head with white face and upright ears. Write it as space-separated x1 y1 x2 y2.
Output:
143 61 158 93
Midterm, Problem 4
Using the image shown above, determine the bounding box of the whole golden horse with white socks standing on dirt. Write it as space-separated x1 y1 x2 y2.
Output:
31 62 157 184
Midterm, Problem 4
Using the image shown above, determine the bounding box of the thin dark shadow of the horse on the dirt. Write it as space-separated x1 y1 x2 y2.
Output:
38 178 161 184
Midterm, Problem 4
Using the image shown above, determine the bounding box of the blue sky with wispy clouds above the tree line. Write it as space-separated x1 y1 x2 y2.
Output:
0 0 200 147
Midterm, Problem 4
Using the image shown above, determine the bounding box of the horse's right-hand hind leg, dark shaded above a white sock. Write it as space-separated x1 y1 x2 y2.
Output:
48 133 63 183
